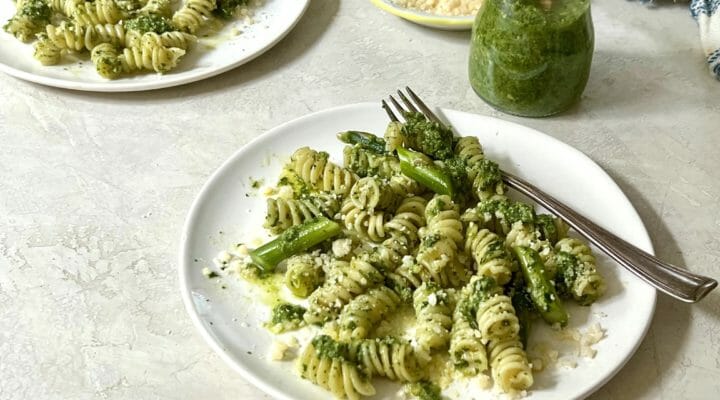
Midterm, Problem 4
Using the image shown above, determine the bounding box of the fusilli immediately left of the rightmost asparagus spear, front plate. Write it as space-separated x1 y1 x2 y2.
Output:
465 222 514 285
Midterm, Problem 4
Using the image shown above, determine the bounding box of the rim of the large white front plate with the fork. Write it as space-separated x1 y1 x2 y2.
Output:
178 102 657 400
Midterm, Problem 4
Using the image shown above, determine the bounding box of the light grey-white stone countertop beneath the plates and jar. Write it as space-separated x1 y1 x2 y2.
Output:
0 0 720 400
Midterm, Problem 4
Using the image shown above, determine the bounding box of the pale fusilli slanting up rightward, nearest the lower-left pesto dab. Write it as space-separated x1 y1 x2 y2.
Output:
305 257 384 324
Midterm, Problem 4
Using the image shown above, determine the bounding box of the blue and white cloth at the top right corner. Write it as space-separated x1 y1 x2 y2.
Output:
690 0 720 79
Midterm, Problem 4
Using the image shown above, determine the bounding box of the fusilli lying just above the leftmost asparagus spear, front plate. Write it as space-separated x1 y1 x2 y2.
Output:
263 193 340 234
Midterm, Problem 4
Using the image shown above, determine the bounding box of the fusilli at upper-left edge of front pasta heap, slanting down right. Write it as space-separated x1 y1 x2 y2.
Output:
291 147 356 196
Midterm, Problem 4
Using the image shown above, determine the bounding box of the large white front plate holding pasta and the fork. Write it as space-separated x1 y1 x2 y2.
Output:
180 103 655 400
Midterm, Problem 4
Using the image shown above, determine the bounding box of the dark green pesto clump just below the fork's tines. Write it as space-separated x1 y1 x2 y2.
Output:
401 113 453 160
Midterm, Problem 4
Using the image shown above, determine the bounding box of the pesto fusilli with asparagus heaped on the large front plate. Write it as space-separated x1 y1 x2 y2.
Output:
221 110 605 399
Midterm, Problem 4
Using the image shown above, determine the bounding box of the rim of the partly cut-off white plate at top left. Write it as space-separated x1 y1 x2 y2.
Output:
0 0 310 93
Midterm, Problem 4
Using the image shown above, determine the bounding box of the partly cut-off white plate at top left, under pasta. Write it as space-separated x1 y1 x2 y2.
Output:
0 0 310 92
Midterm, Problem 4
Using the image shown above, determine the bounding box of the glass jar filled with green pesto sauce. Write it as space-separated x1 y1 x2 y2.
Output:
470 0 594 117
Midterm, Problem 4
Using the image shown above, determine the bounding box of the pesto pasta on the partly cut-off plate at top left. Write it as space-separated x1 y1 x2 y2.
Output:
3 0 263 79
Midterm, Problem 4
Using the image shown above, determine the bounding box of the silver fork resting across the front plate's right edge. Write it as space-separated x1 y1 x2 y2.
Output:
382 87 717 303
